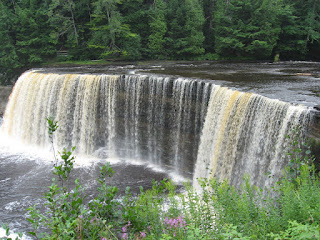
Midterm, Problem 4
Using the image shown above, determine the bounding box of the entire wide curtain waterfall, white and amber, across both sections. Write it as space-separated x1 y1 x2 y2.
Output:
1 71 311 186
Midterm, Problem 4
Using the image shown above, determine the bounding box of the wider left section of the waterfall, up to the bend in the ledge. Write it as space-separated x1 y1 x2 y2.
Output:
2 72 211 178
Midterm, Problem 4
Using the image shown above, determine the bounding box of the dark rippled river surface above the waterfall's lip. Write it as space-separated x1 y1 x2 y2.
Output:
42 61 320 106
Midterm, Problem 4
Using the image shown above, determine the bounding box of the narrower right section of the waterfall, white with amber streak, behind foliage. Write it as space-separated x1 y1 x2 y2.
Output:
193 86 310 188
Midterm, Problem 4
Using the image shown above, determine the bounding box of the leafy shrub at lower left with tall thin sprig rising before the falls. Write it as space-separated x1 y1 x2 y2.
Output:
27 117 117 239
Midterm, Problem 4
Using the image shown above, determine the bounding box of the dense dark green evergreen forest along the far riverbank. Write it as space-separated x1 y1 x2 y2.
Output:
0 0 320 83
